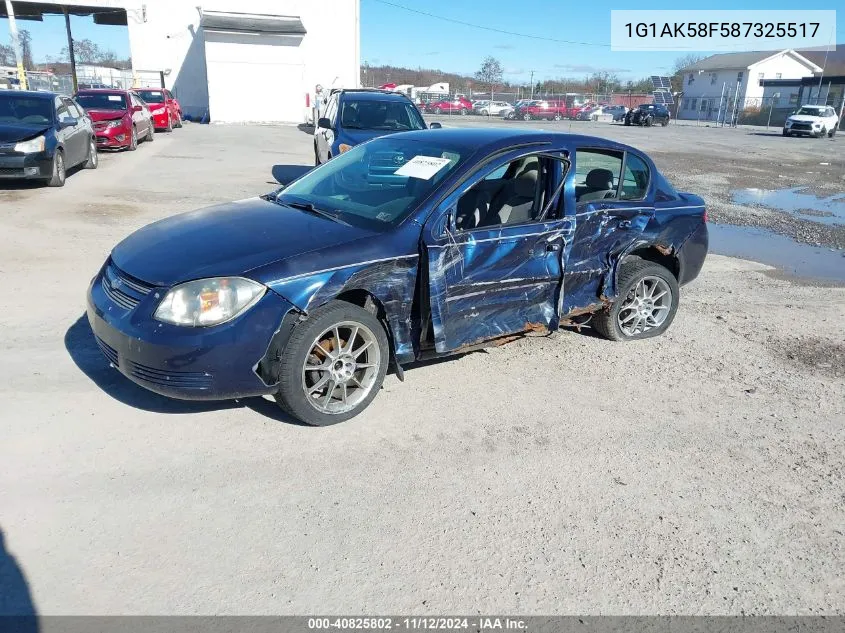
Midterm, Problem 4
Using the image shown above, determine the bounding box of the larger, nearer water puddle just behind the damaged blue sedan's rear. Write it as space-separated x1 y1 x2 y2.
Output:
707 223 845 283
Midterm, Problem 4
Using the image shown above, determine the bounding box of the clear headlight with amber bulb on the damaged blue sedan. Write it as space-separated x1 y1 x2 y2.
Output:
154 277 267 326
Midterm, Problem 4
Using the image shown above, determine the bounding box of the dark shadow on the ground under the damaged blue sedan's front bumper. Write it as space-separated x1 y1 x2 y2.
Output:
64 314 304 426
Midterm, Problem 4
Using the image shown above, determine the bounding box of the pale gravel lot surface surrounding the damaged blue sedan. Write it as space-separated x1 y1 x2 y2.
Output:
0 125 845 614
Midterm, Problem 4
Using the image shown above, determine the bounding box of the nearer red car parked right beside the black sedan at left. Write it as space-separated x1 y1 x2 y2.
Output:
76 89 155 151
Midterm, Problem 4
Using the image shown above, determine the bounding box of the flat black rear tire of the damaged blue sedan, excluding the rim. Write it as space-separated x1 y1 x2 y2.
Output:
592 257 681 341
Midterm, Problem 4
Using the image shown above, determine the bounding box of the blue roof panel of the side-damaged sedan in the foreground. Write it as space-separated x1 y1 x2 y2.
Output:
388 128 643 154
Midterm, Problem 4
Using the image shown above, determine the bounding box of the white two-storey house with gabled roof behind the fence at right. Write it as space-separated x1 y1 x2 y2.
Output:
678 49 821 119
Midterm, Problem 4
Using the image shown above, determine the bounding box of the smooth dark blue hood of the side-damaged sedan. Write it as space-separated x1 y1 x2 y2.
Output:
112 198 373 286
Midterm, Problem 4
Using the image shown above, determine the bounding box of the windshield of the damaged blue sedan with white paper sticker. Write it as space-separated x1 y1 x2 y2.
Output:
270 135 472 230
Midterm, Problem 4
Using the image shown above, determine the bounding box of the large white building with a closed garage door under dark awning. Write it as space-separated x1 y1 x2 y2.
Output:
13 0 360 123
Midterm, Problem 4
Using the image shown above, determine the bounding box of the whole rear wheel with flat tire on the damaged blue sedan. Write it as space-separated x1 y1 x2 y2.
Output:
592 259 681 341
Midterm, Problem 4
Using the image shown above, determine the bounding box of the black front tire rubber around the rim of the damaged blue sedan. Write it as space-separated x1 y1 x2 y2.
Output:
275 301 390 426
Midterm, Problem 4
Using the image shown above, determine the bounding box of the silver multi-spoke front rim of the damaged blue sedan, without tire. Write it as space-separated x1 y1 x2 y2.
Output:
302 321 381 414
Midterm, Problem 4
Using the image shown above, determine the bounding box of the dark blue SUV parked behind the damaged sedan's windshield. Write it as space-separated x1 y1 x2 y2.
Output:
314 88 440 165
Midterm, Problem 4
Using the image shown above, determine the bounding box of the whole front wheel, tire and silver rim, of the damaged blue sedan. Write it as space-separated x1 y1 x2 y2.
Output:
276 301 390 426
